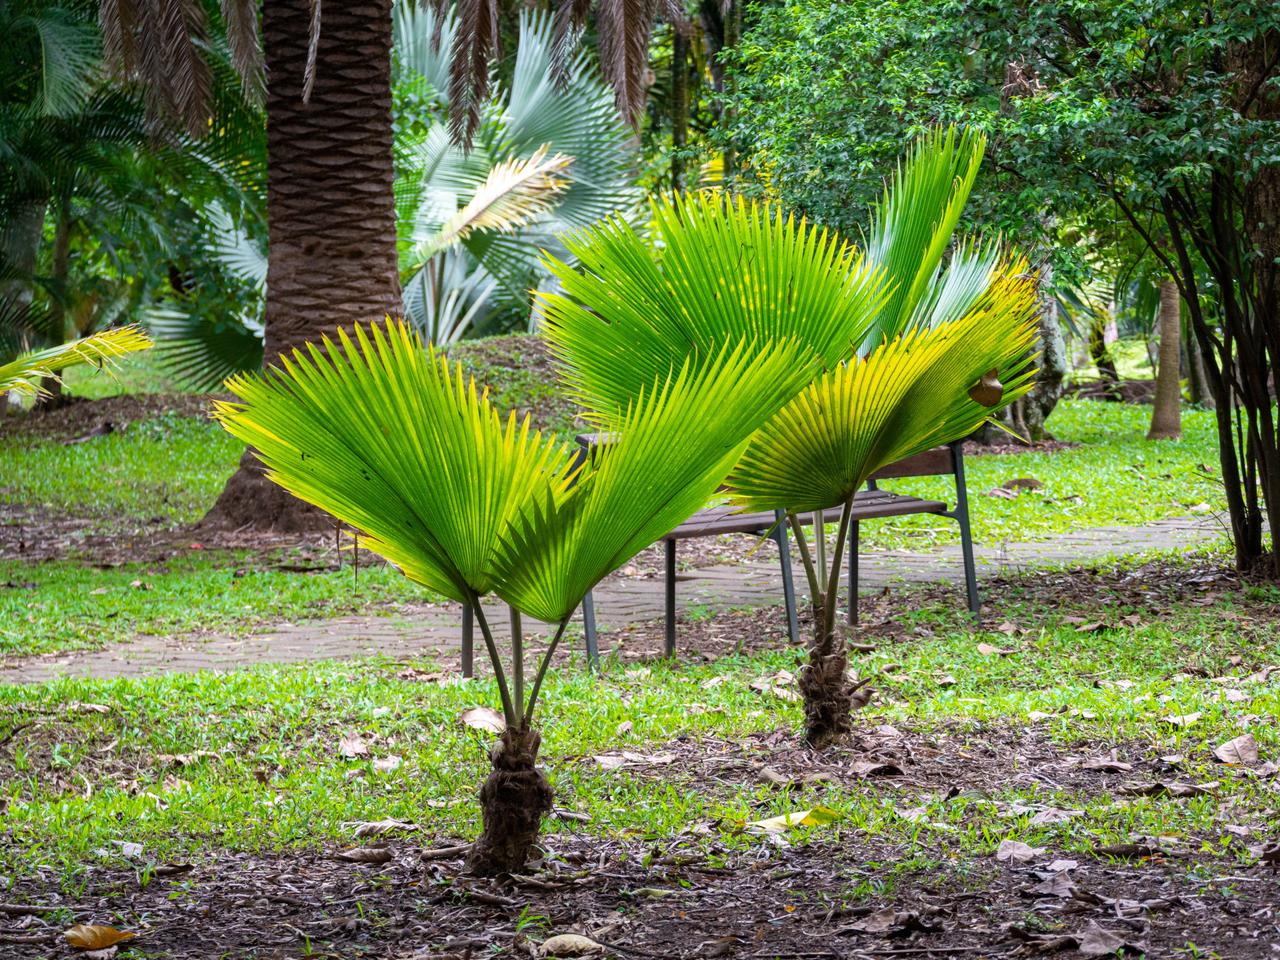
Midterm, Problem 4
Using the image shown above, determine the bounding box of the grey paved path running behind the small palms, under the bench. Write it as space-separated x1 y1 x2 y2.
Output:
0 516 1224 684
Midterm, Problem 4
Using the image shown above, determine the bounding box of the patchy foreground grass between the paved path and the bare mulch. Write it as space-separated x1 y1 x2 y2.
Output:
0 570 1280 877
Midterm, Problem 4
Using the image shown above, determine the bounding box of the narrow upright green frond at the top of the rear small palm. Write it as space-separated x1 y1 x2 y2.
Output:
865 127 998 349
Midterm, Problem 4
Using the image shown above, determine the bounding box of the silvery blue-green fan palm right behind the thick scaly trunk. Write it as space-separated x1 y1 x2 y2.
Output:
396 3 639 343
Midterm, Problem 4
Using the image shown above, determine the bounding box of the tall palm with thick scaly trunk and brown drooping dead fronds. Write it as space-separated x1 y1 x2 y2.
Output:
100 0 684 531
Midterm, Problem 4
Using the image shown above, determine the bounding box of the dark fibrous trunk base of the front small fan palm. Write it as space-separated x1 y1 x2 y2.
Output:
467 728 554 877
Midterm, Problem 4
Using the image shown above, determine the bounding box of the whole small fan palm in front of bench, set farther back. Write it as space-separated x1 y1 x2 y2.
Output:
541 129 1036 745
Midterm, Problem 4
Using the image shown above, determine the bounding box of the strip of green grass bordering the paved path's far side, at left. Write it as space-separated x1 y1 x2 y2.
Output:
0 549 438 655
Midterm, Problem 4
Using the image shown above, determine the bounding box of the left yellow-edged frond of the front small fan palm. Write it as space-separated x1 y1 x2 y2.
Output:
215 324 570 600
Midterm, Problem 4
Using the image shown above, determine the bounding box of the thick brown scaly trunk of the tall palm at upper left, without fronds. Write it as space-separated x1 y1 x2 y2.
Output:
205 0 401 532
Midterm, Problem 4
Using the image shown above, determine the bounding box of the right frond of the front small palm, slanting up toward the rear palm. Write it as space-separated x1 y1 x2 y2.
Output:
497 340 814 621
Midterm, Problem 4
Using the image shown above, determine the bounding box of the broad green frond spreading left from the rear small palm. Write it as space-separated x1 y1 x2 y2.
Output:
538 193 883 424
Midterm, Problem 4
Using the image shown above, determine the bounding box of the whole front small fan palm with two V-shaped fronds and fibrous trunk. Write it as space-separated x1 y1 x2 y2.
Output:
216 324 814 873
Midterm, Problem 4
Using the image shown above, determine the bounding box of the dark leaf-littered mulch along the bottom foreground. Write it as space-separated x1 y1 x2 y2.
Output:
0 831 1280 960
